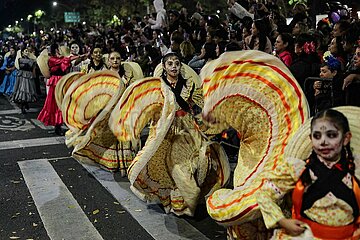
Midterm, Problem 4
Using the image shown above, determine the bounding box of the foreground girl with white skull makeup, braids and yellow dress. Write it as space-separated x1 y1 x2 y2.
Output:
257 107 360 240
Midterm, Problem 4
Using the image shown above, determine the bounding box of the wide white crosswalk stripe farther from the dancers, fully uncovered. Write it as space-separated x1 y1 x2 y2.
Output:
18 159 103 240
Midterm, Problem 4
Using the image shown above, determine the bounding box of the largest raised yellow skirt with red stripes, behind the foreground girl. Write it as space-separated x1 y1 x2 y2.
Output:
200 50 309 239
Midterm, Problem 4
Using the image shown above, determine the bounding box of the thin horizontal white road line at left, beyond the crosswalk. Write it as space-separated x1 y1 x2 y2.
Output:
0 137 65 150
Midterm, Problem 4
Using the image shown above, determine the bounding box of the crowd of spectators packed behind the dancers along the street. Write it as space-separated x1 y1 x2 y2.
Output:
0 0 360 113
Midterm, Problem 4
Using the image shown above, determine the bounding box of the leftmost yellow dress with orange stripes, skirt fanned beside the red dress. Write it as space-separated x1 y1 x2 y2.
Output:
56 63 143 173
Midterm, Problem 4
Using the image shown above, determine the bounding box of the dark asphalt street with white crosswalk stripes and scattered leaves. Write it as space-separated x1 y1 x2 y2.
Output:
0 93 226 240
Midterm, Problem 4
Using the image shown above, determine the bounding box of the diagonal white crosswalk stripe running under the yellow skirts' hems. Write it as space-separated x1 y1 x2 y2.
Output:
82 164 209 240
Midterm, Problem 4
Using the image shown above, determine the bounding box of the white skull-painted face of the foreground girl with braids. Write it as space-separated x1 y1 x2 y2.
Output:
310 118 350 162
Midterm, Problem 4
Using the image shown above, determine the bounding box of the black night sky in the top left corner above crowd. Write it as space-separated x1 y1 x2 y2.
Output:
0 0 52 29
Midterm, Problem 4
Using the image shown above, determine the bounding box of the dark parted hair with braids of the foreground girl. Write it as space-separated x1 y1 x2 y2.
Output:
301 109 355 186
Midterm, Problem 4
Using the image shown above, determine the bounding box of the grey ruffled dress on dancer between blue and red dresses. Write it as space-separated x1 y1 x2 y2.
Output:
11 57 37 103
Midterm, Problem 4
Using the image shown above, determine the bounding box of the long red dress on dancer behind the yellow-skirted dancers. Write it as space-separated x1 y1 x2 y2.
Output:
37 57 71 126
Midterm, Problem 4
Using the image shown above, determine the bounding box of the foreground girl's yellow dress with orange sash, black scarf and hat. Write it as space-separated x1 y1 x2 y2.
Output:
257 106 360 240
